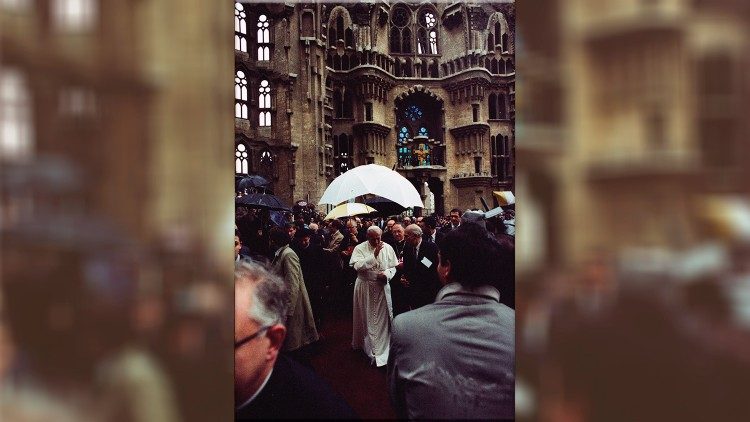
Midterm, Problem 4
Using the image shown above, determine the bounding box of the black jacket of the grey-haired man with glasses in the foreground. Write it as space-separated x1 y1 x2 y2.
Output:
234 354 358 420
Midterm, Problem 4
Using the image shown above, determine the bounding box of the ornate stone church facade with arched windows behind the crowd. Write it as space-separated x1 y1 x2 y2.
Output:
234 1 515 214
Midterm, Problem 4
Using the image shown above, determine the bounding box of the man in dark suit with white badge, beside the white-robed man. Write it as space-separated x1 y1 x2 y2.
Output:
402 224 440 310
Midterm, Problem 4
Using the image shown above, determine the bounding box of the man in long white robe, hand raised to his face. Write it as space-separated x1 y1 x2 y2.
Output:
349 226 398 366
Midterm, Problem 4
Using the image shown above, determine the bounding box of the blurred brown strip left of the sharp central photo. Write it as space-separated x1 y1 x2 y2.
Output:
0 0 234 421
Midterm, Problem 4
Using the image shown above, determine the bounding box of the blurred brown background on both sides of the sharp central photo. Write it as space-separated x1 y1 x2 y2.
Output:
0 0 750 421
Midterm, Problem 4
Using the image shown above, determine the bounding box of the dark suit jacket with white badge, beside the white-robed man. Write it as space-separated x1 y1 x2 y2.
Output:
404 241 440 309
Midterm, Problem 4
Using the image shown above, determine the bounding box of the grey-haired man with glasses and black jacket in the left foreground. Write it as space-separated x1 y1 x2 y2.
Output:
234 261 357 420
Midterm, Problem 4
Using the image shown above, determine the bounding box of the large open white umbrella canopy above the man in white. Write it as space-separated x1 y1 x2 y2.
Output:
318 164 424 208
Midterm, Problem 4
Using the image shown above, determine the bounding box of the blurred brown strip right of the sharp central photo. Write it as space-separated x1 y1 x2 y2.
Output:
516 0 750 421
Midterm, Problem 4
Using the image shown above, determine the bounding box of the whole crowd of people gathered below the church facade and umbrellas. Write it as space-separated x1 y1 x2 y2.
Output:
235 204 515 419
